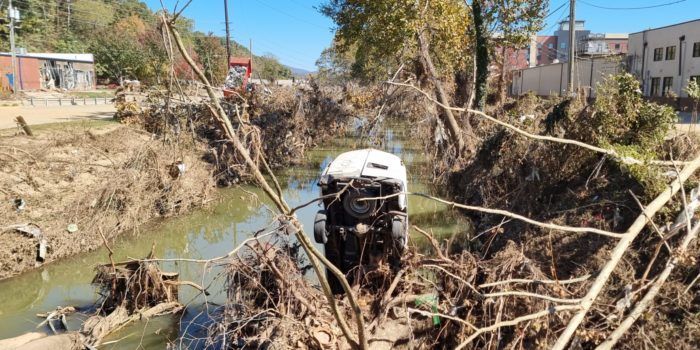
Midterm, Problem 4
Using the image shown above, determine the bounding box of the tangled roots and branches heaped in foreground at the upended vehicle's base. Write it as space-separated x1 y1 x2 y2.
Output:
200 226 604 349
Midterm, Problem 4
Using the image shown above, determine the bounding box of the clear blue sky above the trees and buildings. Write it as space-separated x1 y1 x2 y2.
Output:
145 0 700 70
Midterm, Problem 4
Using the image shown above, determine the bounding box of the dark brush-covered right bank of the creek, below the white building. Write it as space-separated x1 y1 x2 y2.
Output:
426 75 700 348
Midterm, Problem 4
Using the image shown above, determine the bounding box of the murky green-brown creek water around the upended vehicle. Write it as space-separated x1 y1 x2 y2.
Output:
0 129 465 349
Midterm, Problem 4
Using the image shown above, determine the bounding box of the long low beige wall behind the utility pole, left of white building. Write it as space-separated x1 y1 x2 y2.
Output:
511 57 622 97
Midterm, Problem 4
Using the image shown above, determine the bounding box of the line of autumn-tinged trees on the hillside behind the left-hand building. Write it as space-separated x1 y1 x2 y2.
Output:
0 0 292 85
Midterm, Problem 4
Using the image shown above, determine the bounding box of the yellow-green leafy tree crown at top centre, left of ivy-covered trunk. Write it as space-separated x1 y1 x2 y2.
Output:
321 0 471 81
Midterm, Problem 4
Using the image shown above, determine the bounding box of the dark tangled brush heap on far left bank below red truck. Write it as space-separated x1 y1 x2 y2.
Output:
124 84 351 186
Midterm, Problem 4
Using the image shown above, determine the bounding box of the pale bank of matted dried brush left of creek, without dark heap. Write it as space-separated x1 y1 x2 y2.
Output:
0 122 214 279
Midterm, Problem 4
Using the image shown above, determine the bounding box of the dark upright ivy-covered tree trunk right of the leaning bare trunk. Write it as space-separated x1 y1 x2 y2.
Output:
472 0 489 111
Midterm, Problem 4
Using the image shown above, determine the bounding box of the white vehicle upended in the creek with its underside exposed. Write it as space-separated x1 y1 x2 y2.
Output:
314 149 408 292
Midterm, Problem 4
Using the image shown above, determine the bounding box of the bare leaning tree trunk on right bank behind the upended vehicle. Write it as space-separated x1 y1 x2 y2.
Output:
418 31 464 155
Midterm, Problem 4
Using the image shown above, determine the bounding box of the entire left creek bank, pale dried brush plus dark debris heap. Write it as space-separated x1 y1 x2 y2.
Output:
0 86 358 279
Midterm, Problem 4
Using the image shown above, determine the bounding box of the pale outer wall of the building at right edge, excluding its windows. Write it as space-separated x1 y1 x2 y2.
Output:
627 20 700 98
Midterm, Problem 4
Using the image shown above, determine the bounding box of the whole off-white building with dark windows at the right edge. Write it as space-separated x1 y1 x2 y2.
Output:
627 19 700 102
